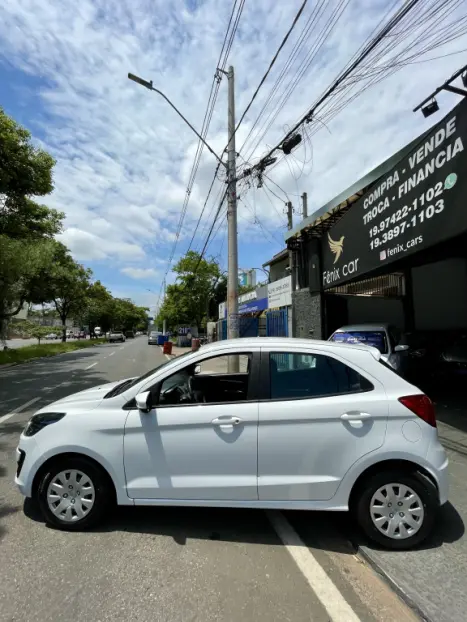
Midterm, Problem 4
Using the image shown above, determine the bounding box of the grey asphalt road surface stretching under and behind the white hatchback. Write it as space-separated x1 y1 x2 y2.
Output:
0 337 460 622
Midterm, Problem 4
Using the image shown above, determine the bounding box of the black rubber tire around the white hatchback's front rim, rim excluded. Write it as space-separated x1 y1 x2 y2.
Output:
37 457 114 531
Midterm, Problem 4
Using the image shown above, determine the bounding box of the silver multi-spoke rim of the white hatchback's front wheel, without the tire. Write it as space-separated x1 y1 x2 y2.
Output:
47 469 96 523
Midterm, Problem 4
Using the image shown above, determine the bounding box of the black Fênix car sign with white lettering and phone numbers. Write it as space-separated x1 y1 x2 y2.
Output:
322 101 467 290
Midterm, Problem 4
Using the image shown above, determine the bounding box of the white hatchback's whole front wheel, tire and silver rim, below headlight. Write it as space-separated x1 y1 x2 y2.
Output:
38 457 113 531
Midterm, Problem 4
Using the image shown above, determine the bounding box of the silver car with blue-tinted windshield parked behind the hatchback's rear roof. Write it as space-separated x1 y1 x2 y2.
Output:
328 324 409 373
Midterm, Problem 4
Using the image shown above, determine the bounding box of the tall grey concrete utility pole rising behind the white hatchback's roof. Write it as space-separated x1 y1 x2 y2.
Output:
227 66 238 339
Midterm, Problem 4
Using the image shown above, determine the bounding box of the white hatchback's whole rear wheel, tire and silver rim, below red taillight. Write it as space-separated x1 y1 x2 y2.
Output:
354 470 439 550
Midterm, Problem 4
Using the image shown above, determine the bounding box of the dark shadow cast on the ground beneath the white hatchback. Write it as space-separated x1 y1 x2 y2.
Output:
24 500 464 555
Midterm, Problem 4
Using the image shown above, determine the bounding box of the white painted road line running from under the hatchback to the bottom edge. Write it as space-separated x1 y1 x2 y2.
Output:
266 510 360 622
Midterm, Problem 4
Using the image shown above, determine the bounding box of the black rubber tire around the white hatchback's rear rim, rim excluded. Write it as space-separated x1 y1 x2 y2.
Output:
351 470 439 551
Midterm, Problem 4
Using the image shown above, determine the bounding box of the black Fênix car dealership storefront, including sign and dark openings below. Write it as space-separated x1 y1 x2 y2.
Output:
287 96 467 346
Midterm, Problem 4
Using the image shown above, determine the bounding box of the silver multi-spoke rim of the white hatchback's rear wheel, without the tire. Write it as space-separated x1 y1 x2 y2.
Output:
370 483 425 540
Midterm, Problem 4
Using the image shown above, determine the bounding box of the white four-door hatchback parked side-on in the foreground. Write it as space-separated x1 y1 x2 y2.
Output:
15 338 448 549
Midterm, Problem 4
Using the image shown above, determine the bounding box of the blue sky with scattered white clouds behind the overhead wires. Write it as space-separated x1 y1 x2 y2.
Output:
0 0 467 308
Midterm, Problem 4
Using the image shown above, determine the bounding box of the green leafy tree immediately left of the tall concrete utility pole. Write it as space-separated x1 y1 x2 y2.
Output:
158 251 222 327
